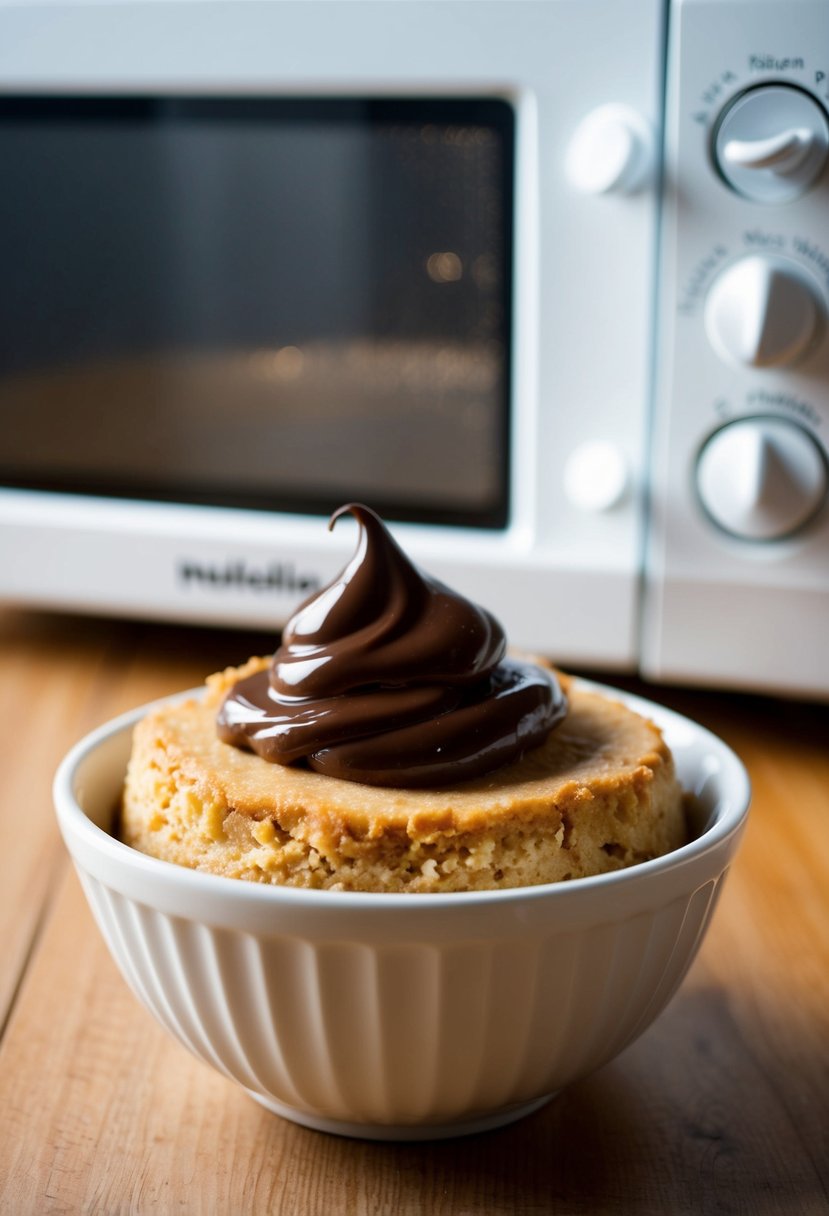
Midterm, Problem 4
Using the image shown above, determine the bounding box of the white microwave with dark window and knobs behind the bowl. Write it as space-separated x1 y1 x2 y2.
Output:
0 0 829 698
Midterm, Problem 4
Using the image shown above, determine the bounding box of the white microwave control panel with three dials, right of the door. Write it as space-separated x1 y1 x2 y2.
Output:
642 0 829 696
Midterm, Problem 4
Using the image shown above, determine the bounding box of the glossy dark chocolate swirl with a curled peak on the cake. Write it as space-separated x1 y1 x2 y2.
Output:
216 503 566 787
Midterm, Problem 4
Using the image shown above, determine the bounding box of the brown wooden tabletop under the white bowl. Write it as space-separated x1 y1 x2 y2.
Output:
0 610 829 1216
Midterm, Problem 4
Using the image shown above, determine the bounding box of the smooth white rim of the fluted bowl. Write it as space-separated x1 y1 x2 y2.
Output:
52 677 751 912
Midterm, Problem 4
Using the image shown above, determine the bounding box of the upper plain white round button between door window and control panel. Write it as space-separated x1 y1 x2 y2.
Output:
564 103 654 195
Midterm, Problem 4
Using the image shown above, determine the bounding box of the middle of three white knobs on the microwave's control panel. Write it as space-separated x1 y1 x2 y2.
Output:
705 254 820 367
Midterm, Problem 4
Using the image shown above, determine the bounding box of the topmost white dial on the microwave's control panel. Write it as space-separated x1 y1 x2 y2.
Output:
714 84 829 203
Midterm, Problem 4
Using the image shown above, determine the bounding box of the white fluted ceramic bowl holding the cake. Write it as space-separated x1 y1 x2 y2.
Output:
55 689 749 1139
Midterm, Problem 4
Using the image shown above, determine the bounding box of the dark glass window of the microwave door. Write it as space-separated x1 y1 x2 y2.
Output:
0 98 513 527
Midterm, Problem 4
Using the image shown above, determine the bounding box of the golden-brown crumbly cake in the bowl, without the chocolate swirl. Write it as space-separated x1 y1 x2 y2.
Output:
122 658 686 893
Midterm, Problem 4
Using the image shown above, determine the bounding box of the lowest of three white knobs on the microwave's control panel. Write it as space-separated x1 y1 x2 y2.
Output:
697 416 827 540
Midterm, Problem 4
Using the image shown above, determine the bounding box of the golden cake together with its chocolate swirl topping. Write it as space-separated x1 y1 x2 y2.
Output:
120 505 686 894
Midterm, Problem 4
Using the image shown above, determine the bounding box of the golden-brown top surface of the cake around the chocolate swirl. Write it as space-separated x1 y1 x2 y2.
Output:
181 671 672 839
